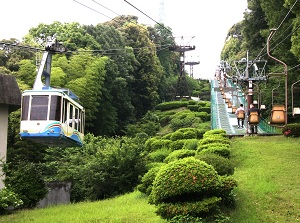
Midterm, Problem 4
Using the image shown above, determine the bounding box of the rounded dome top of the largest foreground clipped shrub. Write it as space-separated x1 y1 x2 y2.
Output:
150 157 221 204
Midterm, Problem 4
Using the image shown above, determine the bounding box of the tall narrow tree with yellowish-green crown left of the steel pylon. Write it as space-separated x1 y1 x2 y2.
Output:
124 23 163 118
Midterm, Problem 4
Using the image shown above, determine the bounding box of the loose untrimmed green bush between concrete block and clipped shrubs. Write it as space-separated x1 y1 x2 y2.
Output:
44 137 148 202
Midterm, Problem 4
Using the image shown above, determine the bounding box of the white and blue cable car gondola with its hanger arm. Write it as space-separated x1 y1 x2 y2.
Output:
20 39 85 147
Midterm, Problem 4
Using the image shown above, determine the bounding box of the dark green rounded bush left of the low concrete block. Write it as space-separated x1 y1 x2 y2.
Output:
4 161 48 208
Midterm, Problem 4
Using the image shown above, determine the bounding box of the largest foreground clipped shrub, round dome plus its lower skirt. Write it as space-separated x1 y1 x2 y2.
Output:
148 157 236 219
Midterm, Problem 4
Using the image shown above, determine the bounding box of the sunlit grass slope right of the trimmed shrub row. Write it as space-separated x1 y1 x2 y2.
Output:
231 136 300 223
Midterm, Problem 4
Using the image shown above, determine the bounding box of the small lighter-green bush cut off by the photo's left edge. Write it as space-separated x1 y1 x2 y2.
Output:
0 188 23 215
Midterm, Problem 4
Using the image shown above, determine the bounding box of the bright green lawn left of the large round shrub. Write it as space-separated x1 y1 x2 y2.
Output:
0 192 166 223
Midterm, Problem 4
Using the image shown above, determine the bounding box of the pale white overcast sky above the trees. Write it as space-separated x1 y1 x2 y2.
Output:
0 0 247 79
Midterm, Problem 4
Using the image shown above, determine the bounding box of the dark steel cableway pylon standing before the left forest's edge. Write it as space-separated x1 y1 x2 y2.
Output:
169 46 196 99
